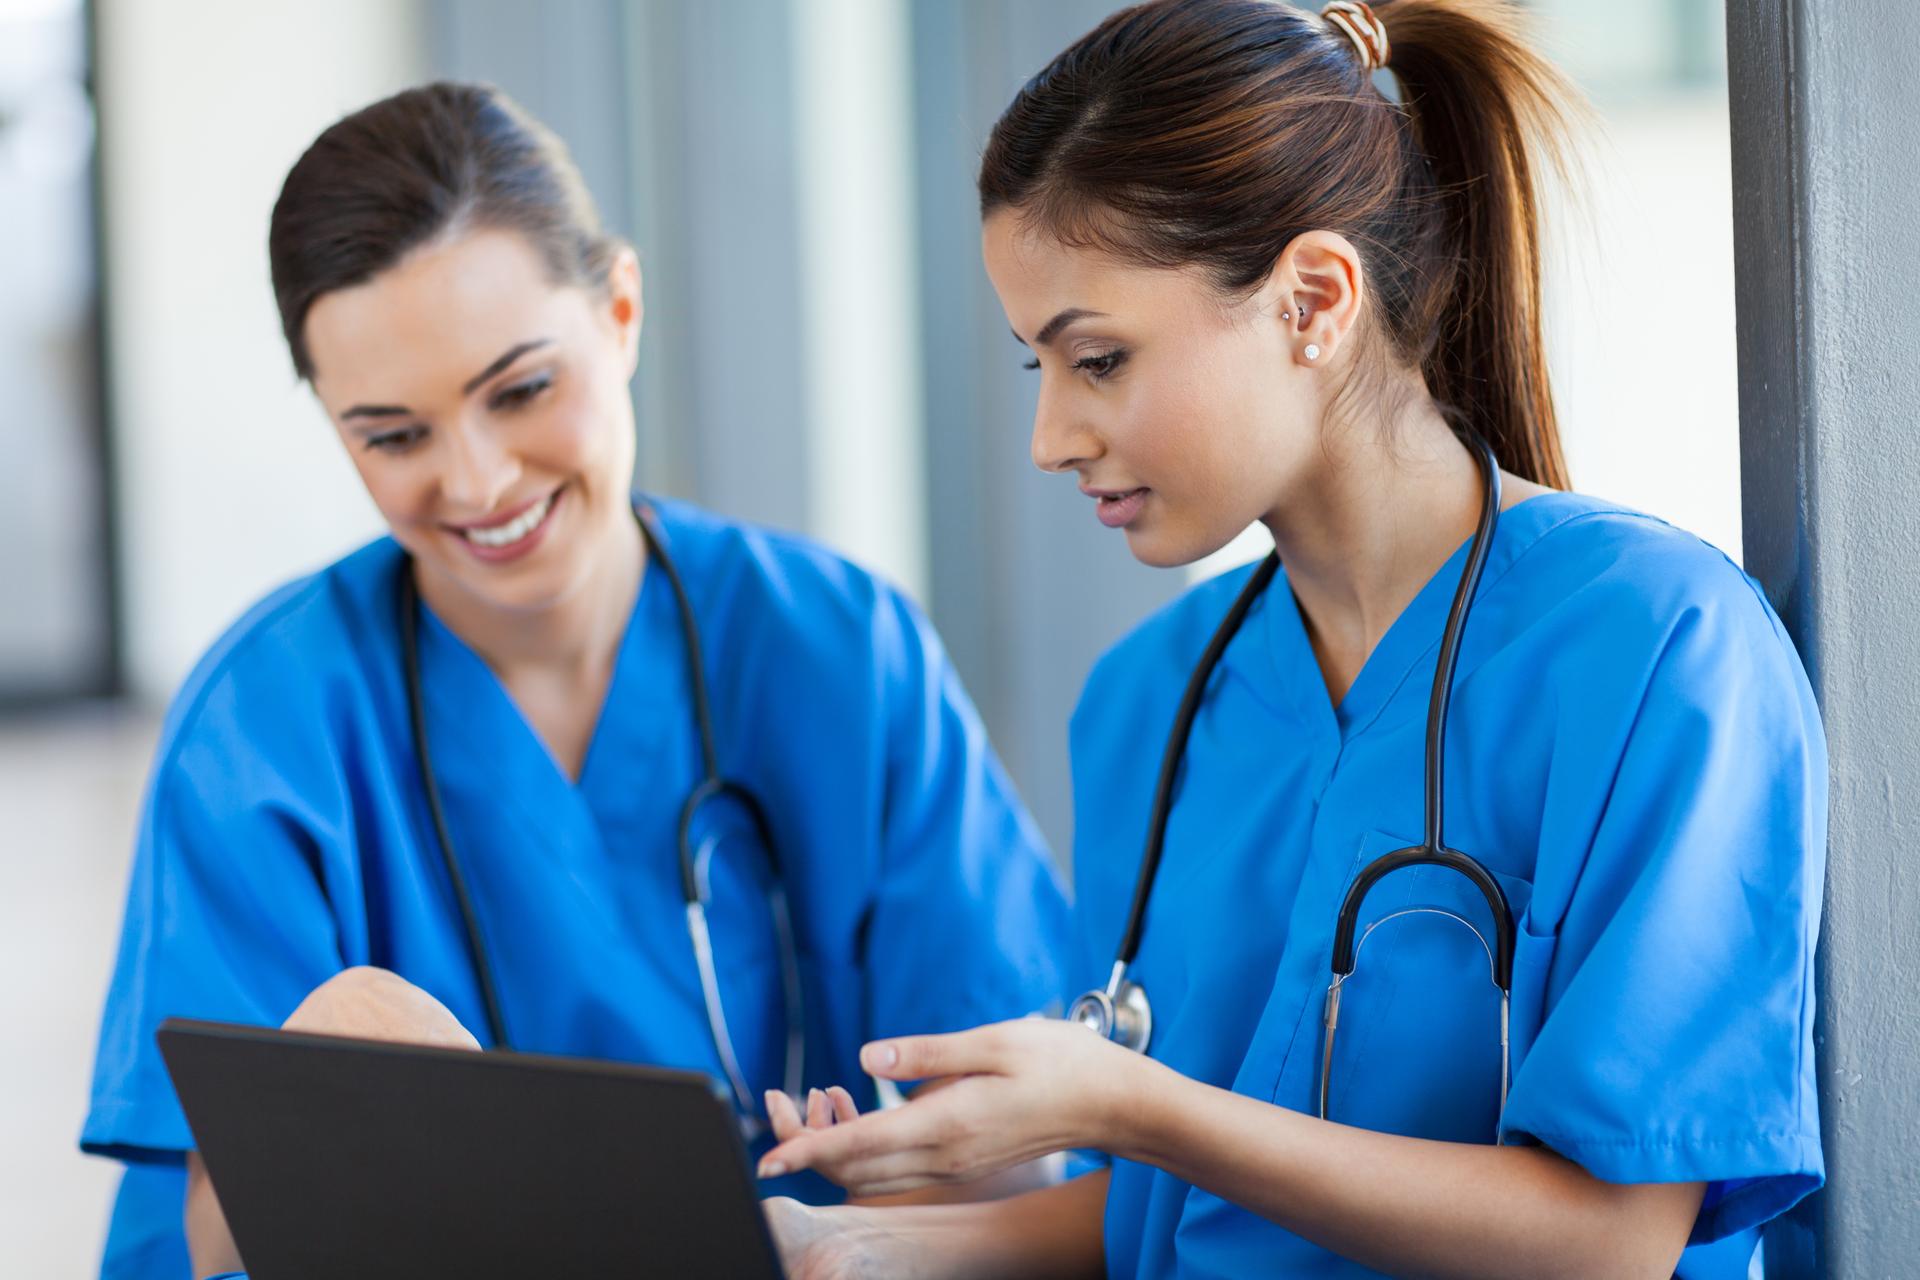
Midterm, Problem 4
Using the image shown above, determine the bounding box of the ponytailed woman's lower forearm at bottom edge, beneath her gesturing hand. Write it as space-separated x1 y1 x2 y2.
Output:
858 1169 1108 1280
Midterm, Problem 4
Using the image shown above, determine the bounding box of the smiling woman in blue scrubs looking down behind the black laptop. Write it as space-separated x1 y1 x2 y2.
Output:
83 84 1066 1276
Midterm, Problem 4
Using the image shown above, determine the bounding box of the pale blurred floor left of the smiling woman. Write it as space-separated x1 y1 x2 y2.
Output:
0 706 159 1278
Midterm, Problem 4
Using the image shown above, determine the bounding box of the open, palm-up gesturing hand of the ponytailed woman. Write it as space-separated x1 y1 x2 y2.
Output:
760 1019 1146 1196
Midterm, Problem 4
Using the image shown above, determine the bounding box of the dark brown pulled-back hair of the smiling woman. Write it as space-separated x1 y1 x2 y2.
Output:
267 83 622 378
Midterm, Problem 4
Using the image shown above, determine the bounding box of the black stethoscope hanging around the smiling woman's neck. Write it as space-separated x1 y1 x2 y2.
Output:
399 505 806 1140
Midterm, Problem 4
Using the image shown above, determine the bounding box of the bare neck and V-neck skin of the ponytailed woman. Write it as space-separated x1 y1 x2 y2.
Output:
1263 390 1482 702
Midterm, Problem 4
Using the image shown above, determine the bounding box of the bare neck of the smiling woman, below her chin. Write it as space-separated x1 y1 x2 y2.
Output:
413 509 647 685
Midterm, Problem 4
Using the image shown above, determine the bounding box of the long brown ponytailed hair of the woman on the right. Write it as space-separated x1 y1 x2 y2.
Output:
979 0 1578 487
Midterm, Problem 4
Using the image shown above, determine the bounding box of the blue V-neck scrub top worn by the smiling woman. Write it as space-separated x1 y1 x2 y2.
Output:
81 503 1069 1276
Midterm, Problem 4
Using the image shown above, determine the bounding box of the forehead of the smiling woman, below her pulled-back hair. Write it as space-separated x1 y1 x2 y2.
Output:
305 230 584 407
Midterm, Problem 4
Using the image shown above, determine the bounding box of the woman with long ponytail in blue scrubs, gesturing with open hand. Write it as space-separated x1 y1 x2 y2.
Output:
762 0 1826 1280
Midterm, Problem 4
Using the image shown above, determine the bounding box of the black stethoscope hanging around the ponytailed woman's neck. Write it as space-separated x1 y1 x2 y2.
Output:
1068 434 1513 1119
